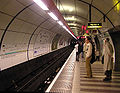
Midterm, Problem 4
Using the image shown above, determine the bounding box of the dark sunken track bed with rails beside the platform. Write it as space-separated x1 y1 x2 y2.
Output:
0 46 73 92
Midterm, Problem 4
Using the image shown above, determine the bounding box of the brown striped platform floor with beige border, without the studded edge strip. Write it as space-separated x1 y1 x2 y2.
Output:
72 58 120 93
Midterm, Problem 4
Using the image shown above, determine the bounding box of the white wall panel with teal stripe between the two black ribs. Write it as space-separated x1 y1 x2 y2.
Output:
0 32 30 69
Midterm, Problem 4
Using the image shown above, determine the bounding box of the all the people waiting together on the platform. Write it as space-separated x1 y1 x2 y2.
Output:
75 37 113 81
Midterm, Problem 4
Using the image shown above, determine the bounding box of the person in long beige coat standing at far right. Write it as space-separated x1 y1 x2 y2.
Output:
103 38 113 81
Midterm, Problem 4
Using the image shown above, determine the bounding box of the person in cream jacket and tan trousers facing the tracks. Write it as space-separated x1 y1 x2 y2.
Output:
85 37 92 78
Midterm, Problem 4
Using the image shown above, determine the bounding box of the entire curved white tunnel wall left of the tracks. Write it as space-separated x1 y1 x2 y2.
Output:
0 0 72 70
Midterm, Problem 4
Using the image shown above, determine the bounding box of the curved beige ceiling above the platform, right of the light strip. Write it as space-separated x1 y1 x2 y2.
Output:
54 0 120 35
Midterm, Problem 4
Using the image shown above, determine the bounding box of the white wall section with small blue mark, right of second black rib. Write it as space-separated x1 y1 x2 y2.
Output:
34 29 52 56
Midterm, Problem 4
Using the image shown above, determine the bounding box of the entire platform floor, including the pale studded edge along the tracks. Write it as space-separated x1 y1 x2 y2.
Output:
46 51 120 93
